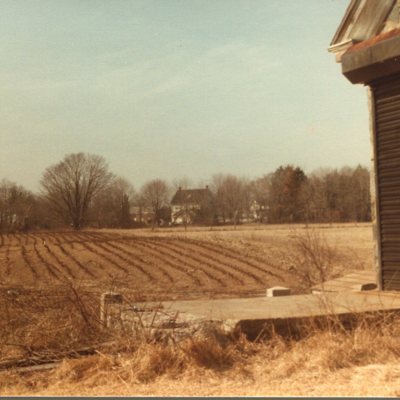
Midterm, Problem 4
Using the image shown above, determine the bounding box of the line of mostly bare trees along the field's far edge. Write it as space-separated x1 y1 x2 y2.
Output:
0 153 371 232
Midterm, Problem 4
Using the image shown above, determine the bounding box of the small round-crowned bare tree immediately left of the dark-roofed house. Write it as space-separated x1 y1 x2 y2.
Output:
141 179 170 229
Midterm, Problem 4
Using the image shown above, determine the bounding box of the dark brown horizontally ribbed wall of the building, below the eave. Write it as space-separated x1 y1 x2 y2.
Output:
371 75 400 290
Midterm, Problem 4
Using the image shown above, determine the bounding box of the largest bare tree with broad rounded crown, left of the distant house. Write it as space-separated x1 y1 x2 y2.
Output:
41 153 112 229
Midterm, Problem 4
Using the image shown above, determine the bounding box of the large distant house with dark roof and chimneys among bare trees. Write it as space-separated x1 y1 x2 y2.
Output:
171 186 213 225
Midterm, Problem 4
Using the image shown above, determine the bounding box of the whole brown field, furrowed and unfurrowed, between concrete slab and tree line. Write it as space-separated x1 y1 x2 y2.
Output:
0 225 372 299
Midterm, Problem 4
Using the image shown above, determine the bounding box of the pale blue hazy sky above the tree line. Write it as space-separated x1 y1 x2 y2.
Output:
0 0 370 190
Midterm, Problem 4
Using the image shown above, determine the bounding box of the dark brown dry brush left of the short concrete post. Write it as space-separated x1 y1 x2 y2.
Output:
0 285 107 362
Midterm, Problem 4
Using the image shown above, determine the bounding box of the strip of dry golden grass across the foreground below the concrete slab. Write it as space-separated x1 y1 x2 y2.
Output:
0 308 400 395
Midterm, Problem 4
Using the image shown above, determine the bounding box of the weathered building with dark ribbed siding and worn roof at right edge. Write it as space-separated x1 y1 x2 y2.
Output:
329 0 400 290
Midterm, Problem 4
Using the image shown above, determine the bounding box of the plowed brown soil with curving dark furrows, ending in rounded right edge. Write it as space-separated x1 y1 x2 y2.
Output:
0 231 289 297
